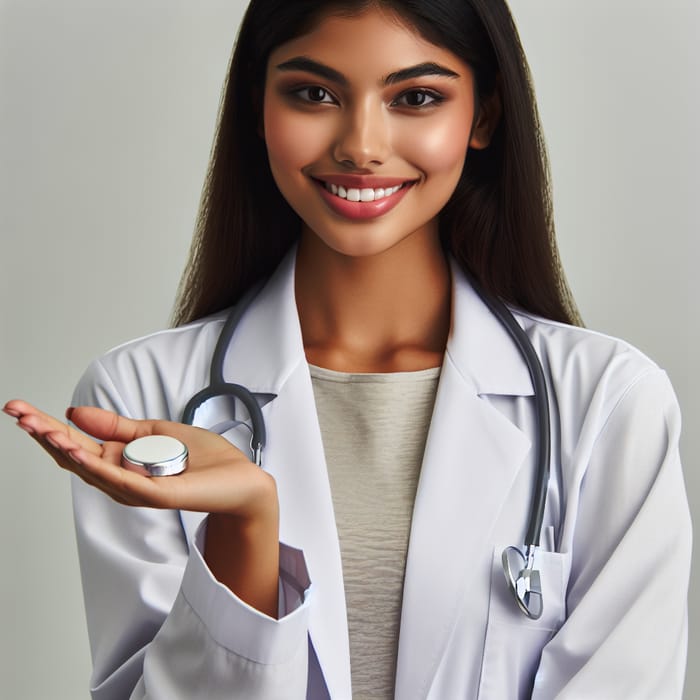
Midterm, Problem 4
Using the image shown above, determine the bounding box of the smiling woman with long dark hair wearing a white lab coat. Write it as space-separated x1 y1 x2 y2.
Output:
6 0 689 698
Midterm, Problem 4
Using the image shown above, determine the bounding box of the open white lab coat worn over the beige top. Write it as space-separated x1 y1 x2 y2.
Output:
69 253 690 700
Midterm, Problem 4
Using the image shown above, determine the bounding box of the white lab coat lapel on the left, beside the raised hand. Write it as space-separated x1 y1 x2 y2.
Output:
217 250 350 697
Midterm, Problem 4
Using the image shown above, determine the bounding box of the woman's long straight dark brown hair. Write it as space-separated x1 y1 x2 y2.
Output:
173 0 580 325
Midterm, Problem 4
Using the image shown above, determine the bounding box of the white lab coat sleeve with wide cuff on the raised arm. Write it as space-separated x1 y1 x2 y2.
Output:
73 362 310 700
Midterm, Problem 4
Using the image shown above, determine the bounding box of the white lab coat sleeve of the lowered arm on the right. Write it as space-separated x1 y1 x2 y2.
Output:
532 369 691 700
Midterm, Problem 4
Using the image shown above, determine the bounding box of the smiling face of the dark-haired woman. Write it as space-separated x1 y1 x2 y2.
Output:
263 4 488 256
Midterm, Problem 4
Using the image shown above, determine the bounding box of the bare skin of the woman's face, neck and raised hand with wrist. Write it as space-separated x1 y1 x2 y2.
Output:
4 9 499 617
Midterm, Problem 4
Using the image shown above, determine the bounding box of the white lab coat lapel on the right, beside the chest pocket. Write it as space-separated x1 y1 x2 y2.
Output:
396 267 532 699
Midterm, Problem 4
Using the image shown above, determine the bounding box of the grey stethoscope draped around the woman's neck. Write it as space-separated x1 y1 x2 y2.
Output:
182 276 550 620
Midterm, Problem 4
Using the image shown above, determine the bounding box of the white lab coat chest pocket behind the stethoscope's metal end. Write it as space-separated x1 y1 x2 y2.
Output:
478 538 571 700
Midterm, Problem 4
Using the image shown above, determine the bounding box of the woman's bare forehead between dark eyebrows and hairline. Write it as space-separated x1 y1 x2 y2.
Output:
268 7 469 79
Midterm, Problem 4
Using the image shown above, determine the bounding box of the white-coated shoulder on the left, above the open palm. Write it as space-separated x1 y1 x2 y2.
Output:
73 311 227 420
